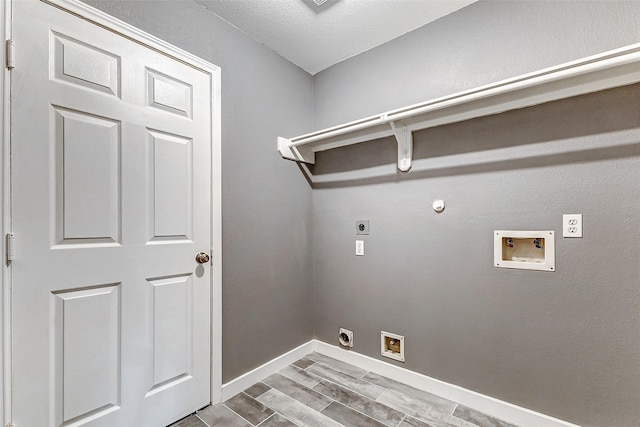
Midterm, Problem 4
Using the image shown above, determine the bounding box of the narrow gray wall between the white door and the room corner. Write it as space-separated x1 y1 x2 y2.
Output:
82 0 313 382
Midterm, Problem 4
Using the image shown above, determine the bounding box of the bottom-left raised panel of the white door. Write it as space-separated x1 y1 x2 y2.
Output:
52 283 121 425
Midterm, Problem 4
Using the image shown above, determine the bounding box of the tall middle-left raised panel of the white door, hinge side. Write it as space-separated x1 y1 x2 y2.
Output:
52 107 121 244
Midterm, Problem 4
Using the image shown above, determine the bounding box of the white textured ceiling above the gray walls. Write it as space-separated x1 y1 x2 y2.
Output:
194 0 476 74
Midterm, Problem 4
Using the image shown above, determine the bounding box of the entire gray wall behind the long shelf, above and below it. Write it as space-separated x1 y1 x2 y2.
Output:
311 1 640 427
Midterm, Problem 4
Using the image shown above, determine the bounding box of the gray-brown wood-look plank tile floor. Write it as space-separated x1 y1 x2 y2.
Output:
170 353 514 427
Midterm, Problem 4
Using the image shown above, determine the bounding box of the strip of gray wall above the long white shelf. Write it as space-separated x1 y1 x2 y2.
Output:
314 0 640 129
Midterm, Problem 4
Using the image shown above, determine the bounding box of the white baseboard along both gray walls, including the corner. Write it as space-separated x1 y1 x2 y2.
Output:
220 339 579 427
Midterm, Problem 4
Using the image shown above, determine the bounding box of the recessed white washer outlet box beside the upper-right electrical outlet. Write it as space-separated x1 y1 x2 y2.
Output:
493 230 556 271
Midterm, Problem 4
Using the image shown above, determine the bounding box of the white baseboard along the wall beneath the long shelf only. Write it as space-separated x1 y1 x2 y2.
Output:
313 340 579 427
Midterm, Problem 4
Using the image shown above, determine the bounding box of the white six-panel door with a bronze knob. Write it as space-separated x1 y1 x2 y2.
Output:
11 0 212 427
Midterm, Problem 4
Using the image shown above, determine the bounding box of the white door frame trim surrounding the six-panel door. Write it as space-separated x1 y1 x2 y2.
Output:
0 0 222 425
